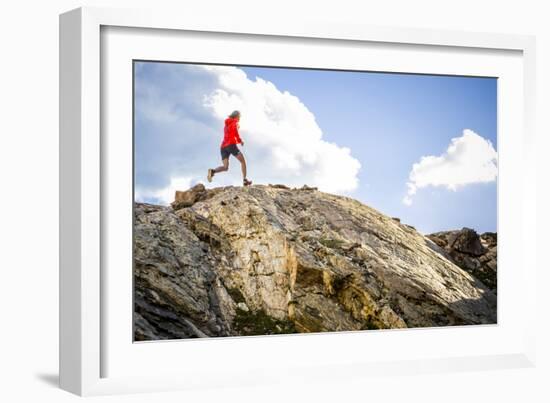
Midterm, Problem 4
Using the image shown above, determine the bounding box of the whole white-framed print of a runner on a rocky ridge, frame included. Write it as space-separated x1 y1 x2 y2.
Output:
60 8 536 395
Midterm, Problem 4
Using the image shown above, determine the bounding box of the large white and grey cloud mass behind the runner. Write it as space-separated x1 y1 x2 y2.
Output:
135 63 360 204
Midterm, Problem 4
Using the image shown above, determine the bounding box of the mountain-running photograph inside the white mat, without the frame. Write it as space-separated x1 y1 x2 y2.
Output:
133 60 504 342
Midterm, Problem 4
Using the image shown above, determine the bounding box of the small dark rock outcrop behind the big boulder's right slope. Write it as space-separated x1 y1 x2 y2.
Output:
428 228 497 294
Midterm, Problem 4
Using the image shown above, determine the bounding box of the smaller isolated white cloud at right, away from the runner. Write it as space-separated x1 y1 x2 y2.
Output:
403 129 498 206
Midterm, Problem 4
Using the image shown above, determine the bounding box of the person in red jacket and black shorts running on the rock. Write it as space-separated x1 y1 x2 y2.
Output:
207 111 252 186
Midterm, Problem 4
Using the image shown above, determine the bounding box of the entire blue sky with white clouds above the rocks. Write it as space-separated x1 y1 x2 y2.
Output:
135 63 497 233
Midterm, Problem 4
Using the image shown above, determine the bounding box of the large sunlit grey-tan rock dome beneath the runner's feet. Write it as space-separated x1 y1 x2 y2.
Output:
134 185 496 340
